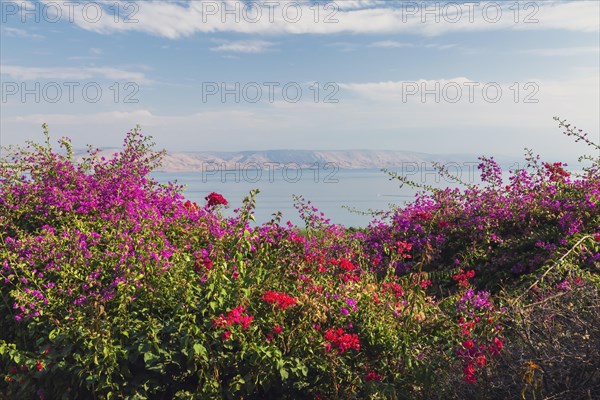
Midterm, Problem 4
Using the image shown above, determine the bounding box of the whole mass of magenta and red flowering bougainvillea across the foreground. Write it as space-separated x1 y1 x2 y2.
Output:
0 120 600 399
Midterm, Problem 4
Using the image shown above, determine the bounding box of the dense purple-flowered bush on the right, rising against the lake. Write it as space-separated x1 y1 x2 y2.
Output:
365 120 600 290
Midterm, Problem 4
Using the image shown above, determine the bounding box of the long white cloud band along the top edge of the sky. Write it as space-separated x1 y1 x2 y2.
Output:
27 0 600 39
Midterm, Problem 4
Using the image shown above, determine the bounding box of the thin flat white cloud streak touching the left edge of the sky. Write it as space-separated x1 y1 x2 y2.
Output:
0 65 151 84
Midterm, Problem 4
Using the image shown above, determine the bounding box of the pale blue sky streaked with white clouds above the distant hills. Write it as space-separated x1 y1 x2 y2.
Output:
0 0 600 160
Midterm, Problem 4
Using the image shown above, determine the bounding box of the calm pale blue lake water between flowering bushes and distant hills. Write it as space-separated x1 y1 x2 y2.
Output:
153 169 478 226
